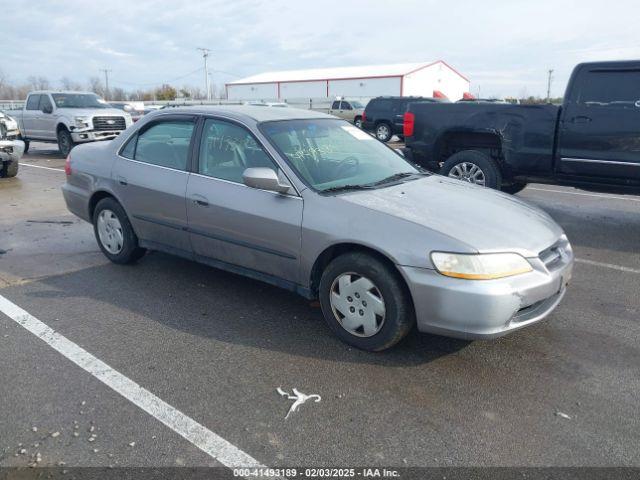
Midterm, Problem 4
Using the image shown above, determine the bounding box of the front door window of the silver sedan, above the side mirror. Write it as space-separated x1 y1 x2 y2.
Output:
198 119 278 183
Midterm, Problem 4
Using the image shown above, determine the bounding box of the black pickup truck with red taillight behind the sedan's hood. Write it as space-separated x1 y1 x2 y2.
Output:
404 60 640 193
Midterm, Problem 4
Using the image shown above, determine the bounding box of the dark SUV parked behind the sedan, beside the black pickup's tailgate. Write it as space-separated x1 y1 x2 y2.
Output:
362 97 443 142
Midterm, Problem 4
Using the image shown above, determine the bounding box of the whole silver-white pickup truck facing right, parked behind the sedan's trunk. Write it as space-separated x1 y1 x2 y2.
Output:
12 91 133 156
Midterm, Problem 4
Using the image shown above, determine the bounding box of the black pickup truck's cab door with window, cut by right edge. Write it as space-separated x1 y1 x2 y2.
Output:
559 68 640 180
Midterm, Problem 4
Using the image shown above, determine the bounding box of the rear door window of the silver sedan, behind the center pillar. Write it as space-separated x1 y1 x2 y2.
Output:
133 120 194 170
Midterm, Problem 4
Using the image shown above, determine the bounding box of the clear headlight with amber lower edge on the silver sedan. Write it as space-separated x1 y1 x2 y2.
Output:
431 252 533 280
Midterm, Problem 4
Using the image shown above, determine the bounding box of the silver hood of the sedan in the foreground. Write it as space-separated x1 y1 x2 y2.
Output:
341 175 563 257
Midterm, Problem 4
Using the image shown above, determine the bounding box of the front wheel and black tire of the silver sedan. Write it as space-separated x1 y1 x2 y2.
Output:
319 252 415 352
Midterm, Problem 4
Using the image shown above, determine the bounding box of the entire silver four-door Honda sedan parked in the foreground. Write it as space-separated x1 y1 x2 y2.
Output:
63 106 573 351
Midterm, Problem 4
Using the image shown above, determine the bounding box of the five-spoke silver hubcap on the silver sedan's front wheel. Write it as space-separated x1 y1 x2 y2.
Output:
329 272 386 337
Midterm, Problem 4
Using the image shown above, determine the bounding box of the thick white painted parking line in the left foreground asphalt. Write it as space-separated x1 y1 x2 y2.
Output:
0 295 264 474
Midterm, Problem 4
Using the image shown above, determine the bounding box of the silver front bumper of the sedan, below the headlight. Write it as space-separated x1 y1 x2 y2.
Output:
399 247 573 340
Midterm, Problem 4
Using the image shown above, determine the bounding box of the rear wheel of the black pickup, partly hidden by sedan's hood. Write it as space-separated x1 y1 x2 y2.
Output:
440 150 502 189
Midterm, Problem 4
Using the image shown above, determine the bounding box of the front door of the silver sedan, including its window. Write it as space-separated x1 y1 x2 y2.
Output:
187 118 303 284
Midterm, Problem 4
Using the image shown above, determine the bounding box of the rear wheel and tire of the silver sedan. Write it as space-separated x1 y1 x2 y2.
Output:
93 197 146 264
